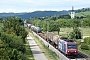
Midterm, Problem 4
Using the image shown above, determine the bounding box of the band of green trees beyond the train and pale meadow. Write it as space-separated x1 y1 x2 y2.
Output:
27 17 90 31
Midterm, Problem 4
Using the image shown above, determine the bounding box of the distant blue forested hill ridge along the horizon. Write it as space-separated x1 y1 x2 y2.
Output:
0 10 71 18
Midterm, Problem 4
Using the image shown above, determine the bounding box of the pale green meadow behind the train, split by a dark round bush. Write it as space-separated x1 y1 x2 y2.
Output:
54 27 90 37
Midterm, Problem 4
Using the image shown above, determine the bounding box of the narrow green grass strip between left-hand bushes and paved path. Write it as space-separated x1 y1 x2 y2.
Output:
25 41 34 60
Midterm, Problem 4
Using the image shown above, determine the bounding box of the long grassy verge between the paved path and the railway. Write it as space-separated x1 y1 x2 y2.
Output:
28 30 59 60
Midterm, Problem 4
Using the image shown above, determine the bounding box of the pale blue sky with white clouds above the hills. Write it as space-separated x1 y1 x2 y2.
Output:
0 0 90 13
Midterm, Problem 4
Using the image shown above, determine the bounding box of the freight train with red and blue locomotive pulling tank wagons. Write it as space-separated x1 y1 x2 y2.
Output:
29 25 78 55
